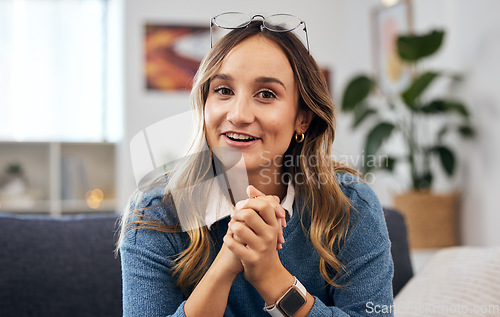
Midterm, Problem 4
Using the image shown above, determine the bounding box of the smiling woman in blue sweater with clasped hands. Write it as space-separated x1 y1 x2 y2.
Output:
119 12 393 317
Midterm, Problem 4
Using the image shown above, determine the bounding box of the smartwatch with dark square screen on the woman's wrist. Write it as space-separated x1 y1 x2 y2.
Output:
264 277 307 317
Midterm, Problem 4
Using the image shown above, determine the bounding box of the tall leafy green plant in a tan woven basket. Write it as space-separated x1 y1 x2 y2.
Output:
341 30 474 248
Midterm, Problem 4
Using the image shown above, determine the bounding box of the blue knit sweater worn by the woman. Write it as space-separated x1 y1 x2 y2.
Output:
120 174 393 317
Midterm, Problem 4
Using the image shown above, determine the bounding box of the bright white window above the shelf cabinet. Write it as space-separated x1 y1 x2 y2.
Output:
0 0 109 141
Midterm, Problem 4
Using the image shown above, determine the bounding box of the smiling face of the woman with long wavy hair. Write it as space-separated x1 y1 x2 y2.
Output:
205 36 307 174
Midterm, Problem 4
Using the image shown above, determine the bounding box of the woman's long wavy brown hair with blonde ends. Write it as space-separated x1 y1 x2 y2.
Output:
118 21 359 291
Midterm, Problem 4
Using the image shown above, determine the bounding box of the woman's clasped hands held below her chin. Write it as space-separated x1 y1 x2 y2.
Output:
224 185 286 286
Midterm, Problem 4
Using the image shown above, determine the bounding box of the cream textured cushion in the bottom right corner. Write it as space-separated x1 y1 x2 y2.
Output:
394 247 500 317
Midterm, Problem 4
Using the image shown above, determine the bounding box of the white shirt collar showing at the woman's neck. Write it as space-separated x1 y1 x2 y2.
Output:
205 181 295 229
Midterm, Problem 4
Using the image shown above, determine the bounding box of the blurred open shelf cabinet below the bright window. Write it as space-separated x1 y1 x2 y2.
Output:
0 142 116 216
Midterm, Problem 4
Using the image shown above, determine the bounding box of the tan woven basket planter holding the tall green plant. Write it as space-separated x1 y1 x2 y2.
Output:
394 191 459 249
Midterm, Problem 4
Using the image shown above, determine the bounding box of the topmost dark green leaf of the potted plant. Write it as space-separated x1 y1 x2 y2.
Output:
397 30 444 62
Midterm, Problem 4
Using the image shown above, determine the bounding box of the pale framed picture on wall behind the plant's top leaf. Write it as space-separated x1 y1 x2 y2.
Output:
372 0 413 97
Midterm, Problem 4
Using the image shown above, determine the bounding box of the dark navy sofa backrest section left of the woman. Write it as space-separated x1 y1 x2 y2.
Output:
0 214 122 317
